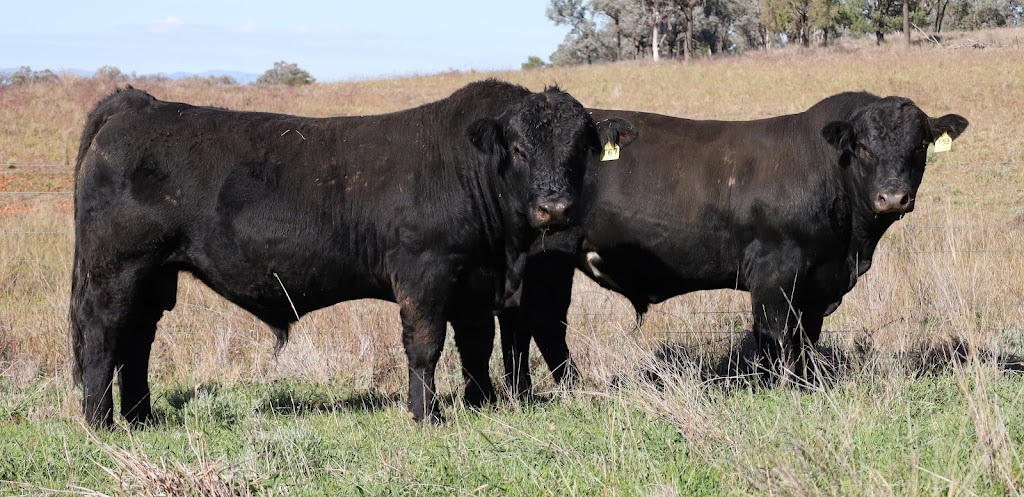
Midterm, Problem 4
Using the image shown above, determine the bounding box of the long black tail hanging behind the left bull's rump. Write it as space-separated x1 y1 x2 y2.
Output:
68 86 155 384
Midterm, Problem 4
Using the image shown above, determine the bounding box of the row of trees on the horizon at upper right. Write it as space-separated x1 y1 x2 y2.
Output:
547 0 1024 65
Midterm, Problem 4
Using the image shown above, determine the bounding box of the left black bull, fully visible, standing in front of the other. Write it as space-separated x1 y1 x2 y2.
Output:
70 81 630 425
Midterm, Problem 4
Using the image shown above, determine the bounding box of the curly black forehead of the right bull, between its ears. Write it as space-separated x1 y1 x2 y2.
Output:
856 96 931 150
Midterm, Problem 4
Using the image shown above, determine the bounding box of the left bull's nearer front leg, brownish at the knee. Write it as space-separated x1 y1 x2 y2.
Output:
398 288 445 423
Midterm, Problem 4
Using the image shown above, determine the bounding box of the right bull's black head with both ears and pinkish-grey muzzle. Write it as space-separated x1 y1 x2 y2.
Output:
821 96 968 214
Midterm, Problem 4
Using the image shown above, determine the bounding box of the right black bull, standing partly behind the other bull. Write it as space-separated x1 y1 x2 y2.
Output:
500 93 968 390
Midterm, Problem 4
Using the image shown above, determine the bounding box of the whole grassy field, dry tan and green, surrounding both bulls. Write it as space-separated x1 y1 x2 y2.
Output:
0 34 1024 496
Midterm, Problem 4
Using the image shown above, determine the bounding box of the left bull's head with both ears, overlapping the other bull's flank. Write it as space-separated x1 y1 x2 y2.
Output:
467 87 632 229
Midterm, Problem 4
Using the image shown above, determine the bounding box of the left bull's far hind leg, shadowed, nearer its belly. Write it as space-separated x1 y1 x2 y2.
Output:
117 270 178 424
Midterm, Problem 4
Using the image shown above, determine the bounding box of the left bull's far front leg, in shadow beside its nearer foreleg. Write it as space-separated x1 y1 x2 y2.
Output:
452 310 498 407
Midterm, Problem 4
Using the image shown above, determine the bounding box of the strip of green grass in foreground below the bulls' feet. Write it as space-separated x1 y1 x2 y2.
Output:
0 365 1024 496
